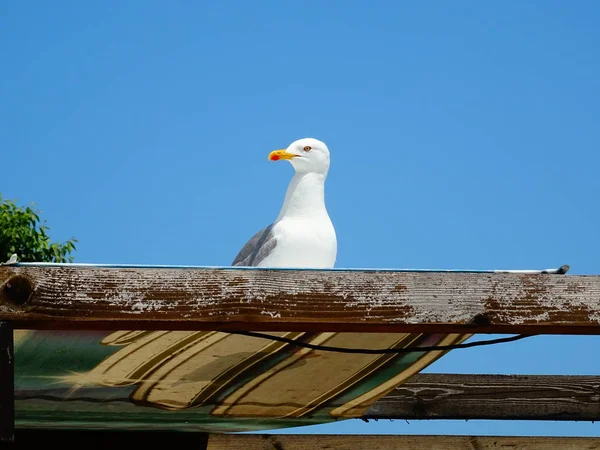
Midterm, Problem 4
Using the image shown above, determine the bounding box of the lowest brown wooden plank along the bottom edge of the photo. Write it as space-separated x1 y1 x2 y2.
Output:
208 434 600 450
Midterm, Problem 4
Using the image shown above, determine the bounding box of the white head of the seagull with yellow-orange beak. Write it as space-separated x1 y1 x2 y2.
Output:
269 138 329 175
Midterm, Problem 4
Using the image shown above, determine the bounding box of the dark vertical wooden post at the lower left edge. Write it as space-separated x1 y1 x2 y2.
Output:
0 321 15 442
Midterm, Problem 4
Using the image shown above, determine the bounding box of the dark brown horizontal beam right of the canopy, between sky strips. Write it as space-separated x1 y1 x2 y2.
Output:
363 374 600 421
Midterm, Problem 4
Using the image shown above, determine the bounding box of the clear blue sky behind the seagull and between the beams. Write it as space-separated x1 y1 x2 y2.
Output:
0 0 600 435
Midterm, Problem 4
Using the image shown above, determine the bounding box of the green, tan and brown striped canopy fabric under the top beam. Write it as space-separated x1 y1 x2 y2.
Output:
15 330 468 432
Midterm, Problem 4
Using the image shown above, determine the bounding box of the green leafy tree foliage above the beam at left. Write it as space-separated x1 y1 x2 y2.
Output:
0 195 77 263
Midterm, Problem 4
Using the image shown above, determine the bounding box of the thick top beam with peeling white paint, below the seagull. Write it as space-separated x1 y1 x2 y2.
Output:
0 266 600 334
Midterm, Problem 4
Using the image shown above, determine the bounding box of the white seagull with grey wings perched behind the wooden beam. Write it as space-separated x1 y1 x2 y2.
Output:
232 138 337 269
